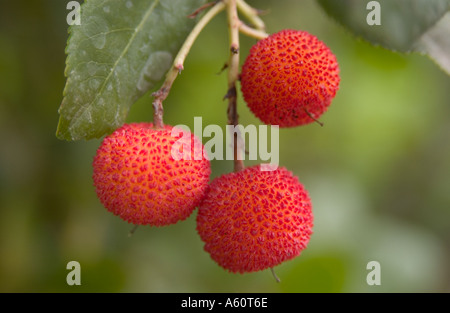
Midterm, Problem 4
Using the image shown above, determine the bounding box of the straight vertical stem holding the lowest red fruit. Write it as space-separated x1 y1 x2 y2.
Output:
225 0 245 172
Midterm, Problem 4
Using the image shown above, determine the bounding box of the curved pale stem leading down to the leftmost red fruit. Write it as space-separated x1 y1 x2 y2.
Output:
152 1 225 129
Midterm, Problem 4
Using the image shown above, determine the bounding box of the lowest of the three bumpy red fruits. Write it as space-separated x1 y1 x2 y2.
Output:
197 166 313 273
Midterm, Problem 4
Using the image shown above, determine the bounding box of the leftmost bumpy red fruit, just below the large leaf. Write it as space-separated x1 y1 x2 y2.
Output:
93 123 211 226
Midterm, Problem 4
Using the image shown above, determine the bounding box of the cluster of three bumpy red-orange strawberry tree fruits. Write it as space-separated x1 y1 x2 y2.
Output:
93 30 339 273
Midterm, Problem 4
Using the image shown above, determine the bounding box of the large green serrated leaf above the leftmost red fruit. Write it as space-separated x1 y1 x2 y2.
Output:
56 0 206 140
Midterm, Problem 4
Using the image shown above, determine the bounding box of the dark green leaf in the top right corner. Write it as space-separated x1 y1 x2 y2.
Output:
318 0 450 74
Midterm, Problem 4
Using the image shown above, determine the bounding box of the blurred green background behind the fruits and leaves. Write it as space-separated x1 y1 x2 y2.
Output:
0 0 450 292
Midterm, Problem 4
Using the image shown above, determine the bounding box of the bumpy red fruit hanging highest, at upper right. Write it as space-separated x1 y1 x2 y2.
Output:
241 30 340 127
